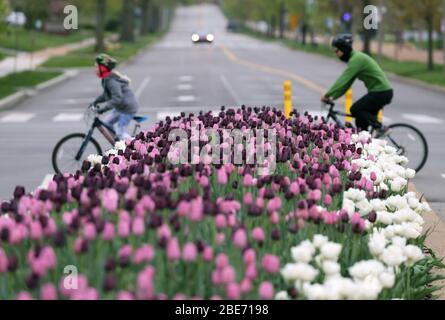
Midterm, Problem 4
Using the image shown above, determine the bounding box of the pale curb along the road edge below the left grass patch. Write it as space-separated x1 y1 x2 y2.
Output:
0 70 79 110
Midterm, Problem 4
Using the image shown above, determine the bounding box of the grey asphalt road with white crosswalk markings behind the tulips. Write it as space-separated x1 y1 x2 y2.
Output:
0 5 445 218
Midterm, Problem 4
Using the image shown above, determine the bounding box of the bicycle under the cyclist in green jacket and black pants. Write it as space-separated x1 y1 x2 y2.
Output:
322 101 429 172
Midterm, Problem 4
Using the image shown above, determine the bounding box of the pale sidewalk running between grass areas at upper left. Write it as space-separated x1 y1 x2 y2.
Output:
0 38 95 77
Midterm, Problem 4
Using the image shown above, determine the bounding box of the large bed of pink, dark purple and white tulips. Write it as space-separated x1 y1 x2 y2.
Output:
0 107 443 299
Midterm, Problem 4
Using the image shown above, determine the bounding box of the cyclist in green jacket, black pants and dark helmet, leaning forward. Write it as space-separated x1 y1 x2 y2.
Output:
321 34 394 130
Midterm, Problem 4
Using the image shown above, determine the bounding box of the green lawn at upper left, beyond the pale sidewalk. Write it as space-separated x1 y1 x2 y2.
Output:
0 28 91 52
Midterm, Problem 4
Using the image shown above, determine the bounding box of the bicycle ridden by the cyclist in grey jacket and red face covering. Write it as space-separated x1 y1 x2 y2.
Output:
51 108 148 174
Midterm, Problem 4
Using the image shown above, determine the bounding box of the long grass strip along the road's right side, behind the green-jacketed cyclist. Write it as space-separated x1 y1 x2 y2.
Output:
232 30 445 87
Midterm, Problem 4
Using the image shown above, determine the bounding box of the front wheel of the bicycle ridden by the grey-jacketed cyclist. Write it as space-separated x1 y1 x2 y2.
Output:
52 133 102 173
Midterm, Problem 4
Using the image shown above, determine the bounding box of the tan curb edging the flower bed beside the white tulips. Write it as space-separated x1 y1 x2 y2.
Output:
409 183 445 300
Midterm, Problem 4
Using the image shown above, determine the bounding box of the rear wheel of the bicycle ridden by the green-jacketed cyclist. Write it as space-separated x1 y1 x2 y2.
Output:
382 123 428 172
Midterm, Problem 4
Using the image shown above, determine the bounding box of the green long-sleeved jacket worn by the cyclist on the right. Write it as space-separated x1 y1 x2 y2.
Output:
325 50 392 100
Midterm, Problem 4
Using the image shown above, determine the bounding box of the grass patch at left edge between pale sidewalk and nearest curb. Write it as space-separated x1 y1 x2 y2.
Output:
0 71 61 99
